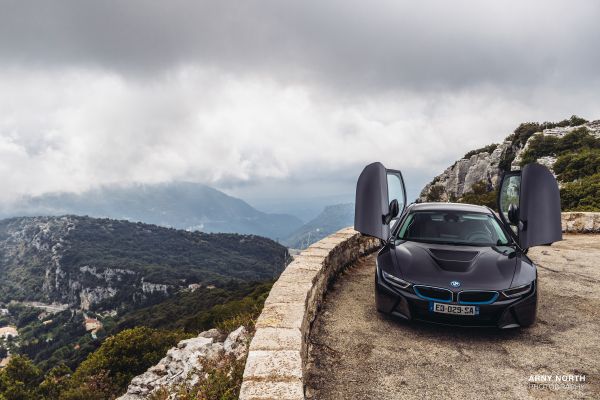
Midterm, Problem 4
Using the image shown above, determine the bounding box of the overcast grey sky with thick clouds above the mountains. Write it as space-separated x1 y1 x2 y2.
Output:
0 0 600 211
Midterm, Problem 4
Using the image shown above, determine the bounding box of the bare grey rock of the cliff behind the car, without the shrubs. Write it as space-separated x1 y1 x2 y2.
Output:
419 117 600 201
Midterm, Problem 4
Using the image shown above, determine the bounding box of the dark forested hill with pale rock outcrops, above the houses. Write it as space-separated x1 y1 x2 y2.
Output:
0 216 287 310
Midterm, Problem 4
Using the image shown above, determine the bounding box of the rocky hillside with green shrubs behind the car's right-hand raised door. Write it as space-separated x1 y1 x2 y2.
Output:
420 116 600 211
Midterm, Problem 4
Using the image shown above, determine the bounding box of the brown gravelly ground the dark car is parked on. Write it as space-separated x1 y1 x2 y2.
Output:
306 235 600 400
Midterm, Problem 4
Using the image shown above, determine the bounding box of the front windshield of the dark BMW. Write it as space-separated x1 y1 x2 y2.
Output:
397 211 509 246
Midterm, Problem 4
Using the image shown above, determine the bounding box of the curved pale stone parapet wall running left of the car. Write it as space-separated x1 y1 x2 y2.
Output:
240 228 379 400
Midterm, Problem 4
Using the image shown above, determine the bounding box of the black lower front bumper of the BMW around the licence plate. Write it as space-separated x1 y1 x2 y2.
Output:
375 269 537 329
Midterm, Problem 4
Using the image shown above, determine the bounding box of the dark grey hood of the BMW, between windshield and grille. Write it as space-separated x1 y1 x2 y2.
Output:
394 242 519 291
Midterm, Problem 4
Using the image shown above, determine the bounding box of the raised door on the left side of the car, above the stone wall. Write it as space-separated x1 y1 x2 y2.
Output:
354 162 406 240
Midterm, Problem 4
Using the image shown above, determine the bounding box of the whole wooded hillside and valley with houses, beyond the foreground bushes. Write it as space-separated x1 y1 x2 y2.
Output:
0 216 289 371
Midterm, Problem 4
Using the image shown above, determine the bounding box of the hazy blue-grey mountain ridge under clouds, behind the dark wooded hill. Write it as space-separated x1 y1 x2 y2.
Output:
0 182 302 239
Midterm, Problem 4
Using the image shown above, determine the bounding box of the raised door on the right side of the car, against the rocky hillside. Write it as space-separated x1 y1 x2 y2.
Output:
497 164 562 249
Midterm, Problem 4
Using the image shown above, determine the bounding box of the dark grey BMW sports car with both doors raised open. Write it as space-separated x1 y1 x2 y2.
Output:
354 163 562 328
